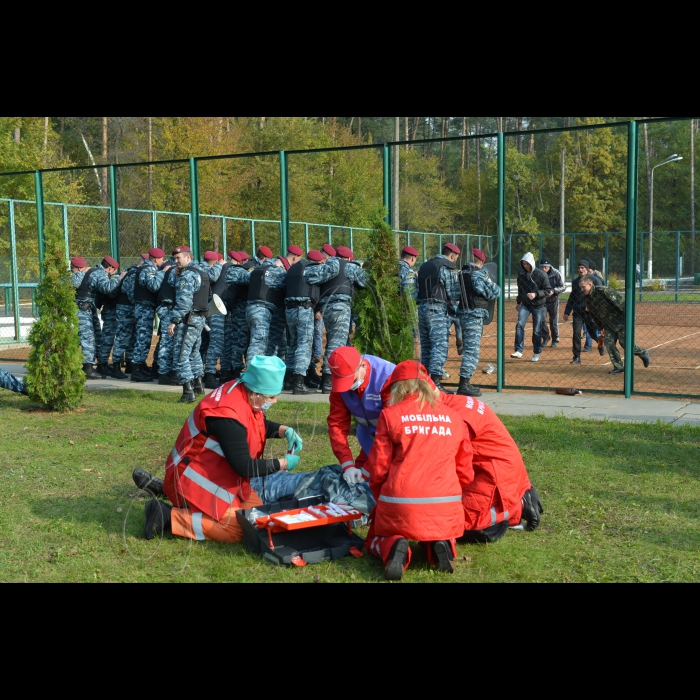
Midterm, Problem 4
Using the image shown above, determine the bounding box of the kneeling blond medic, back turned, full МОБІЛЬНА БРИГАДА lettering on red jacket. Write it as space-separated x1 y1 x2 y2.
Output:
365 361 474 581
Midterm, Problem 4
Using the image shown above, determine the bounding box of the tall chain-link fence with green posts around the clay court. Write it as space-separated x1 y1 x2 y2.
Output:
0 118 700 396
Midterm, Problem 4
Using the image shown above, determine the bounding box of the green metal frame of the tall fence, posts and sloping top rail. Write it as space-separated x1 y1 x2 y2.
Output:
0 117 698 398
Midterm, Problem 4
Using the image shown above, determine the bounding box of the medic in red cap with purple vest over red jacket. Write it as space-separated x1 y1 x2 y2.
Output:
328 347 396 484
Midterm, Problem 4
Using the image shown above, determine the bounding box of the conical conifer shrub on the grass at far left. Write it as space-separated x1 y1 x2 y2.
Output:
26 226 85 411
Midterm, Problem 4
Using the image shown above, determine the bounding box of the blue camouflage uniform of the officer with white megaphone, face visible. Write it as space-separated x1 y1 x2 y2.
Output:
172 263 206 386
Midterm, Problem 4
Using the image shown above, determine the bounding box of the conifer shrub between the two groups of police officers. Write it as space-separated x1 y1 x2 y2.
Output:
355 220 418 364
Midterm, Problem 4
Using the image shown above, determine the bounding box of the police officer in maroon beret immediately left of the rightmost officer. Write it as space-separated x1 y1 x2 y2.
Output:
418 243 461 393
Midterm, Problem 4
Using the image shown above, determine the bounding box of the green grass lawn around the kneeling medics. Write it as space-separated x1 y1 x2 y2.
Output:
0 391 700 583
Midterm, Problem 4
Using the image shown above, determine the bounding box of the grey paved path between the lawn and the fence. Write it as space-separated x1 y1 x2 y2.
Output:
5 364 700 427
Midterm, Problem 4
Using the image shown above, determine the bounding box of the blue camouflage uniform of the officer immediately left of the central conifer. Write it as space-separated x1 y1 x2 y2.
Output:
304 258 369 374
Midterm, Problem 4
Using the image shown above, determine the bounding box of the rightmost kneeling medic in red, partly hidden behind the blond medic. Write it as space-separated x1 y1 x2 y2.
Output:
442 394 544 544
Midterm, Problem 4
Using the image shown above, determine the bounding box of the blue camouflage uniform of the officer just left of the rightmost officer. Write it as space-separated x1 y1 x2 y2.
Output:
418 255 460 377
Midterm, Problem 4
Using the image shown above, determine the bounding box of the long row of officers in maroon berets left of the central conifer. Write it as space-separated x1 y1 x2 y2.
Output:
71 245 369 403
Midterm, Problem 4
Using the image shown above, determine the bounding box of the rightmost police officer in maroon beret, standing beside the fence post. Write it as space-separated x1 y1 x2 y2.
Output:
457 248 501 398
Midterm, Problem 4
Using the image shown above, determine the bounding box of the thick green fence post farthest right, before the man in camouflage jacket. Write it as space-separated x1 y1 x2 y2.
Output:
625 121 639 399
